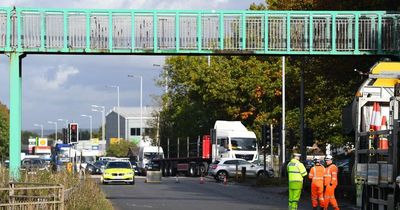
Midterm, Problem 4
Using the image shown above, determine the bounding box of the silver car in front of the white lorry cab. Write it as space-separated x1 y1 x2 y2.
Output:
208 158 274 181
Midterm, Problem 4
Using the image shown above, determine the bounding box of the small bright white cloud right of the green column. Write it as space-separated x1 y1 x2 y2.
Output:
33 65 79 89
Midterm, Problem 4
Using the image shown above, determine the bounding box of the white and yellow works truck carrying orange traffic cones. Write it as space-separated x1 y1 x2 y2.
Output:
353 61 400 210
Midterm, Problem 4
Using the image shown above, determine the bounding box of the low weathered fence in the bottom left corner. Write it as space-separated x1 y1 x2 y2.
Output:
0 182 65 210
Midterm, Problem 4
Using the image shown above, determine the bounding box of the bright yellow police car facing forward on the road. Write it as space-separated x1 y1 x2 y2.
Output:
101 161 135 184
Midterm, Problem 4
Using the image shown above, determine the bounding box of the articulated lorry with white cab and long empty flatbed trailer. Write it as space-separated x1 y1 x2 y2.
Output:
153 120 258 176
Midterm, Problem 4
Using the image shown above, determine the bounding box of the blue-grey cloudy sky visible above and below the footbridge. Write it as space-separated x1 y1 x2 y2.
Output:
0 0 264 130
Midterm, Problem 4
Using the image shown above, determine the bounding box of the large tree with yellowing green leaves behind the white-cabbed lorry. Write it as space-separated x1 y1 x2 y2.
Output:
160 56 290 141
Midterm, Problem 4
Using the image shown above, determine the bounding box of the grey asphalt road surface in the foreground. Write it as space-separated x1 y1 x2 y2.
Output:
102 177 311 210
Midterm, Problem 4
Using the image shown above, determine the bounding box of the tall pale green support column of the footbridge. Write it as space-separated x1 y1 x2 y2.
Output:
8 52 25 181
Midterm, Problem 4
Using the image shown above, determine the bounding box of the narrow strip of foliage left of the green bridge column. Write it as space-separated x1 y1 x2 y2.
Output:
0 102 10 159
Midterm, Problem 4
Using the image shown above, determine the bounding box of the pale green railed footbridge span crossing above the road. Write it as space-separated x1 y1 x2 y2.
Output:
0 8 400 55
